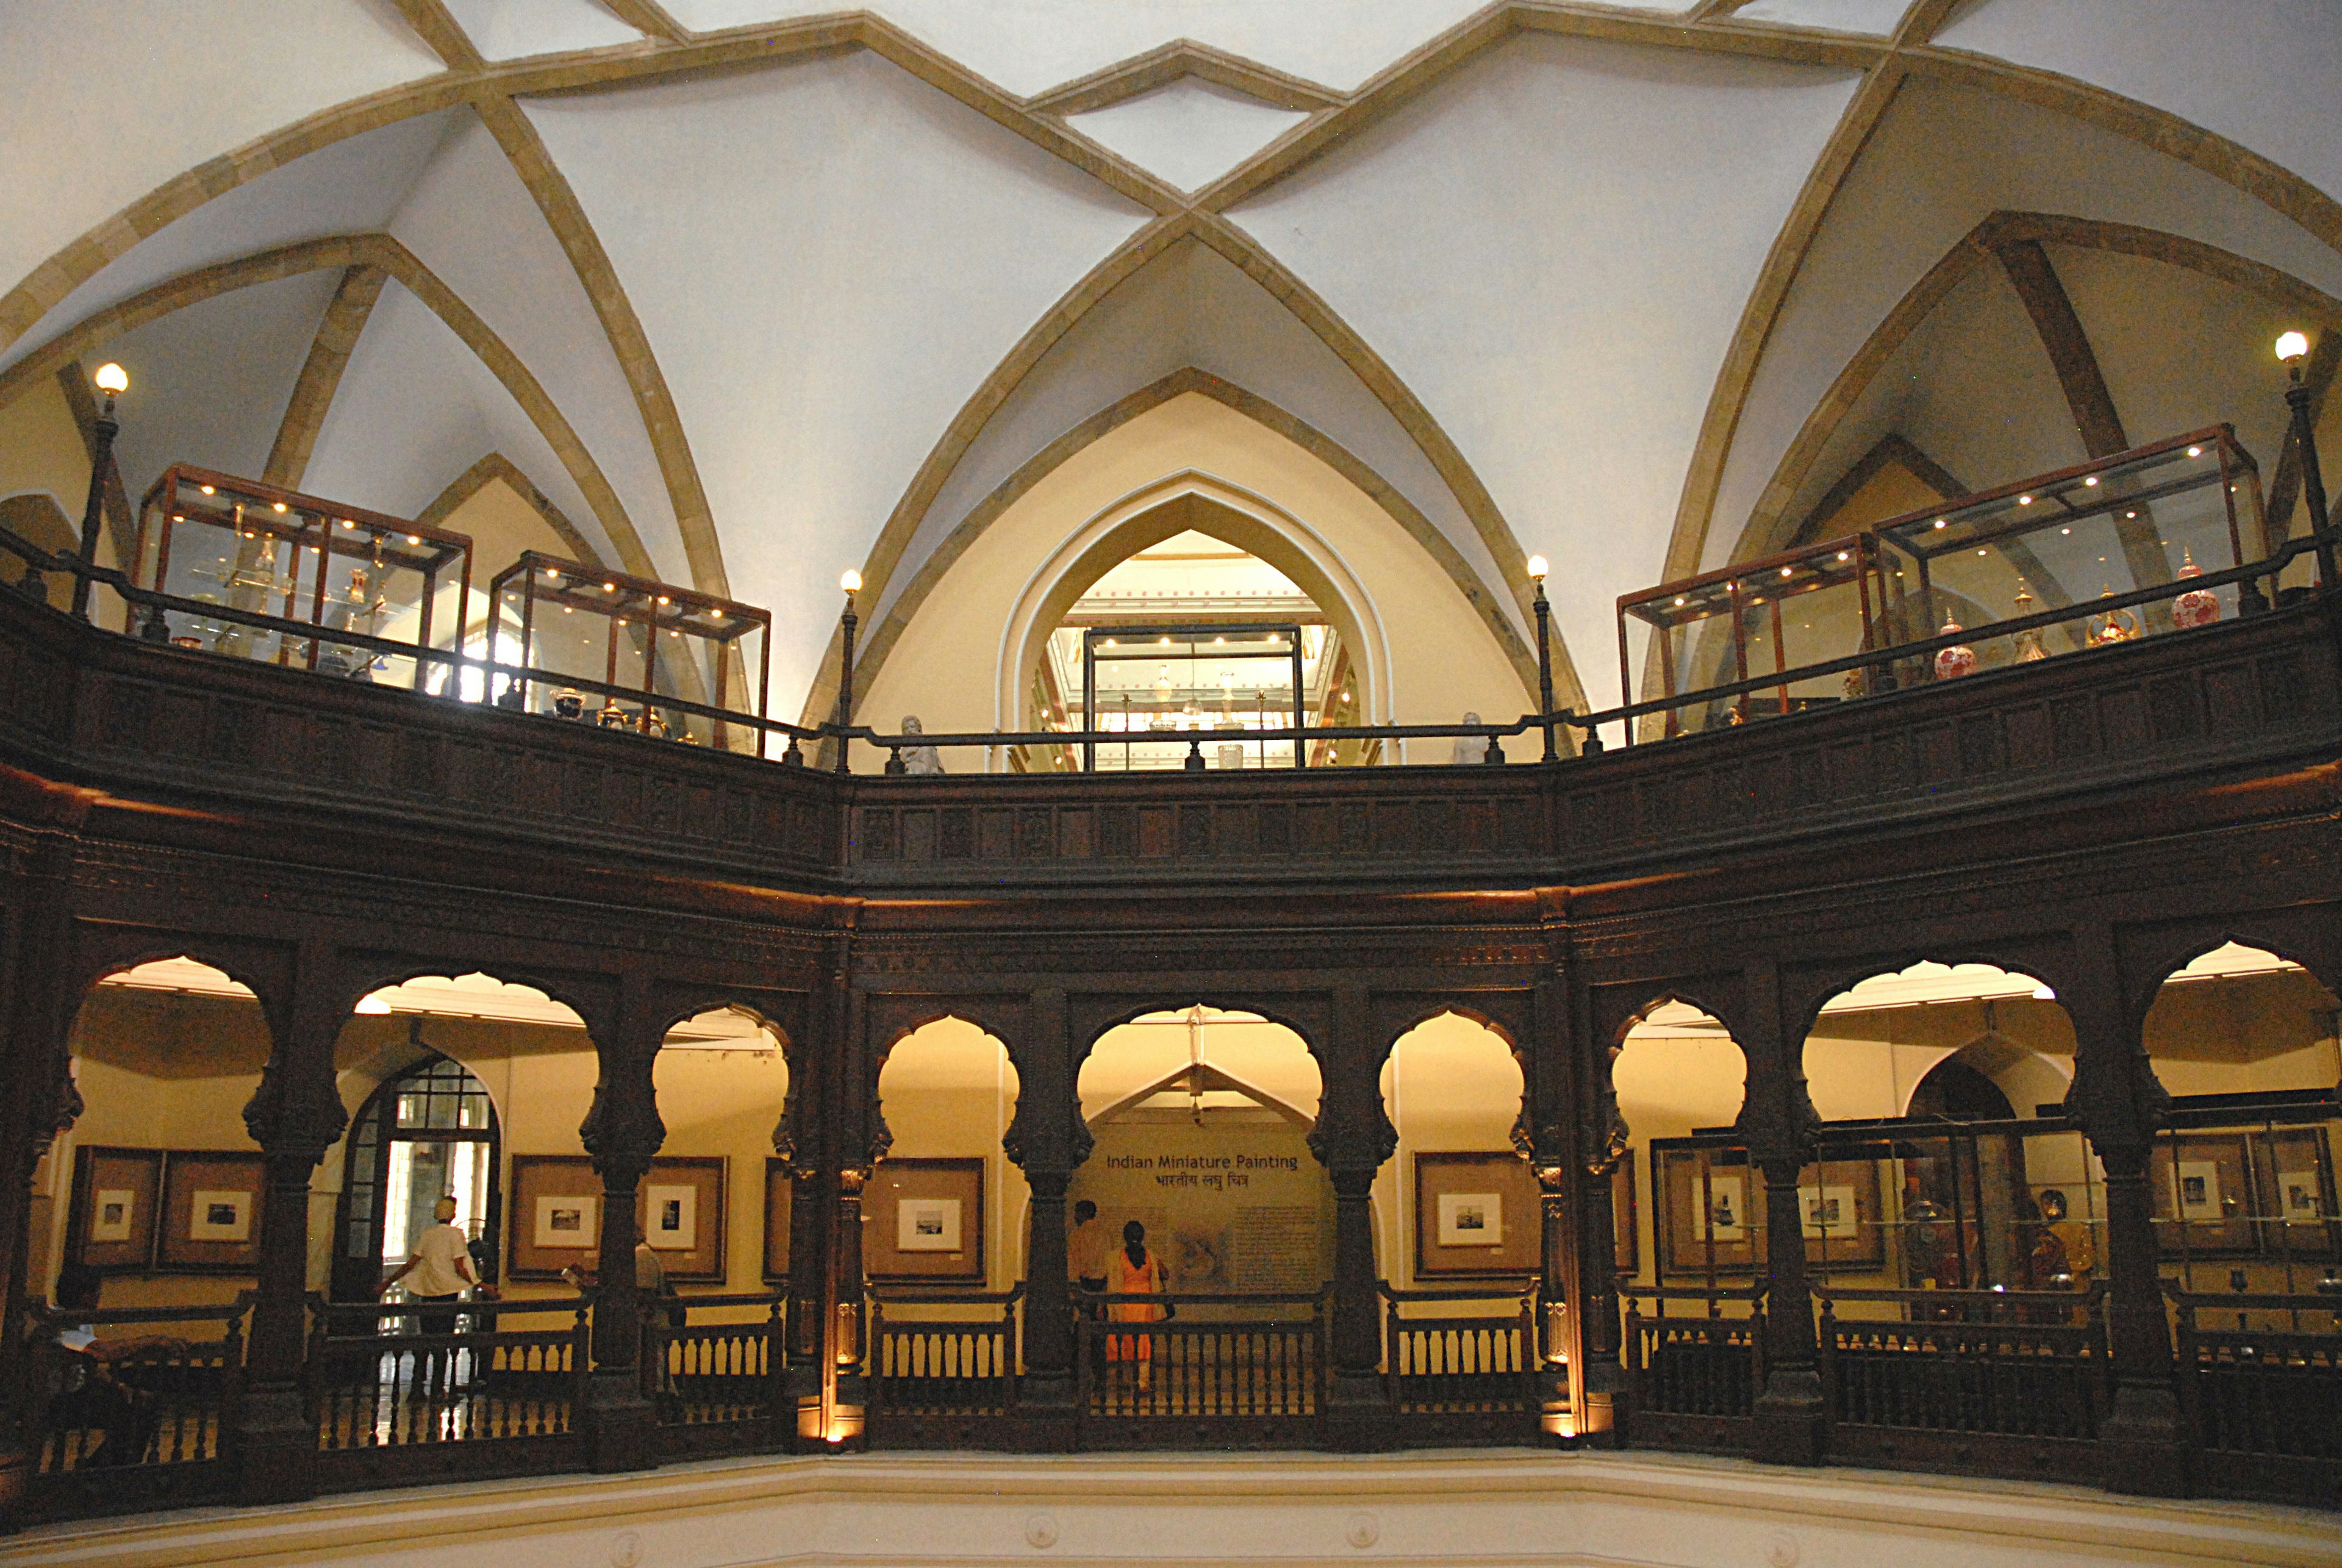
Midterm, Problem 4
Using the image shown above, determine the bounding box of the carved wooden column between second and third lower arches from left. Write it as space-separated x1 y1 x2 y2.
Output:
578 973 667 1470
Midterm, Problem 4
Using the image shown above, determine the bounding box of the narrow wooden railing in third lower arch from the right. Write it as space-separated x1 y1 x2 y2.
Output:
1618 1285 1766 1448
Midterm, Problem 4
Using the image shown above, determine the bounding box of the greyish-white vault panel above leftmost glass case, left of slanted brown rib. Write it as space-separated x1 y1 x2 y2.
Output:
84 271 342 498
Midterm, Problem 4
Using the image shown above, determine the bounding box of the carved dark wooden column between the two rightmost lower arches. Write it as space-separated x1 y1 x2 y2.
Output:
2058 925 2190 1498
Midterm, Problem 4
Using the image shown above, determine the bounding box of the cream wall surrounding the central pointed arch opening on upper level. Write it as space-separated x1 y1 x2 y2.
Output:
859 393 1534 772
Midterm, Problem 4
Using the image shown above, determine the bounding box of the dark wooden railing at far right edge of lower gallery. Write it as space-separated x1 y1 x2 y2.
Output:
2164 1283 2342 1507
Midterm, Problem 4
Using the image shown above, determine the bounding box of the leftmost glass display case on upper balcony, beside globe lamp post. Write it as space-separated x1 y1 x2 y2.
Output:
131 464 471 690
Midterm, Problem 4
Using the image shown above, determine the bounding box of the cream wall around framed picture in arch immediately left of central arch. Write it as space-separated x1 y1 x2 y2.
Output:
878 1018 1031 1289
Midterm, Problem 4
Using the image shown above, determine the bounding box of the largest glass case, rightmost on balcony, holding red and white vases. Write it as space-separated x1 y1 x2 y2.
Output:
1876 426 2265 681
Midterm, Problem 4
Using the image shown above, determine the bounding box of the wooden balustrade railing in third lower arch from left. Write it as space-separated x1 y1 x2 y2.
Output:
642 1292 797 1451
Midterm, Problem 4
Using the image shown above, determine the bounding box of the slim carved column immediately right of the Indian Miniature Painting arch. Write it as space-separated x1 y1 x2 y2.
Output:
1309 981 1398 1448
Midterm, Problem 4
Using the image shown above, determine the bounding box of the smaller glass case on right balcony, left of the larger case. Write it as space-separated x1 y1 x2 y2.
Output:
1618 534 1878 735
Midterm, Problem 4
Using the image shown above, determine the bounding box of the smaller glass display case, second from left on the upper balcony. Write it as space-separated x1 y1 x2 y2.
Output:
490 550 773 751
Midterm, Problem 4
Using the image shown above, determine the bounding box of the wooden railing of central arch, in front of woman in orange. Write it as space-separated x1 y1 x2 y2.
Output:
1077 1289 1330 1444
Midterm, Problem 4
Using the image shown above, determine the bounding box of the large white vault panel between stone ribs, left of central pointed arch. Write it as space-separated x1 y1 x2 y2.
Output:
529 51 1143 690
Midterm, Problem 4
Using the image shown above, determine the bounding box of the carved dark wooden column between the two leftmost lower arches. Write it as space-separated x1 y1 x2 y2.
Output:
234 941 349 1503
